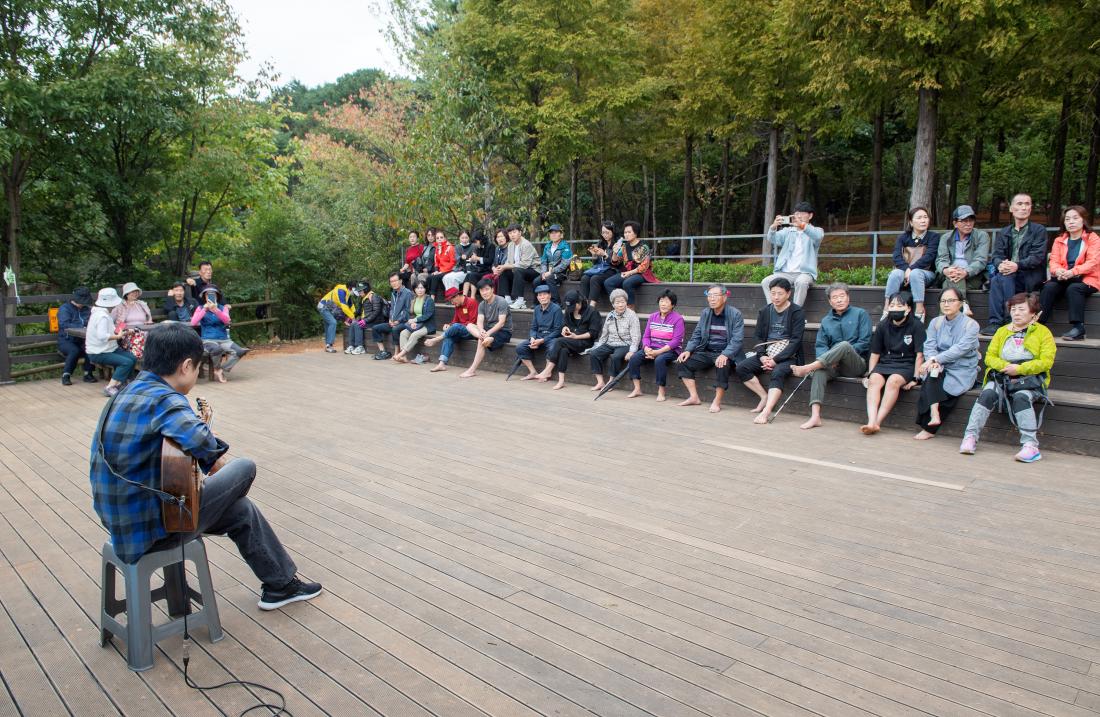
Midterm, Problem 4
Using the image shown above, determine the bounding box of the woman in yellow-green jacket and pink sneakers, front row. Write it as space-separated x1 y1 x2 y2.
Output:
959 294 1058 463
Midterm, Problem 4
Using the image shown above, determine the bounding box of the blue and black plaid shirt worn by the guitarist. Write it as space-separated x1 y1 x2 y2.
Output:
88 371 229 563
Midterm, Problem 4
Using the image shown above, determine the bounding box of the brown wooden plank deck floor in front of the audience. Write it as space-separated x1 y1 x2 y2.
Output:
0 345 1100 717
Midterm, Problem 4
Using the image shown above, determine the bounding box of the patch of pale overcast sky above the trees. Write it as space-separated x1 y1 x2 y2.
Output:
230 0 408 87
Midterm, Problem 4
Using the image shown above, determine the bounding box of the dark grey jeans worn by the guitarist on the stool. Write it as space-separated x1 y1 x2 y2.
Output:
150 459 298 589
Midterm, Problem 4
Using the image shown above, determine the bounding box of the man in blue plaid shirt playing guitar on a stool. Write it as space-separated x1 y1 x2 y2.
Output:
89 322 321 610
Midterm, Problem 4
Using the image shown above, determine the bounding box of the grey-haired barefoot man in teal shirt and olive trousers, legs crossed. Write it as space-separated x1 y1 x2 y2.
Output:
791 284 871 429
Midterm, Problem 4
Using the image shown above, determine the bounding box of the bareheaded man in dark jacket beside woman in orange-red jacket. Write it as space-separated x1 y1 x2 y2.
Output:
981 191 1046 337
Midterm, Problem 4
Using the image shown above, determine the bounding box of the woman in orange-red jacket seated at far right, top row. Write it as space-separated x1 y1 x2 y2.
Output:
1040 205 1100 341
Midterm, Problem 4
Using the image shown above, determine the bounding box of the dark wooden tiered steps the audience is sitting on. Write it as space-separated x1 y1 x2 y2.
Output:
420 284 1100 456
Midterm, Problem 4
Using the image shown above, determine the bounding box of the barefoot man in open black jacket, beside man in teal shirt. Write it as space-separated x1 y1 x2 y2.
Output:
737 276 806 426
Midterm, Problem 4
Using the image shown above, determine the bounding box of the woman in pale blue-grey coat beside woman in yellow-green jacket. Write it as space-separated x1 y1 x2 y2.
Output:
913 287 980 441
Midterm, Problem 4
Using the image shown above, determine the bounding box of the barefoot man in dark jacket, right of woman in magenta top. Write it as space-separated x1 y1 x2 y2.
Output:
677 284 745 413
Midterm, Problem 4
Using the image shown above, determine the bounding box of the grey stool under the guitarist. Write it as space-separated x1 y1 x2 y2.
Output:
99 537 223 672
